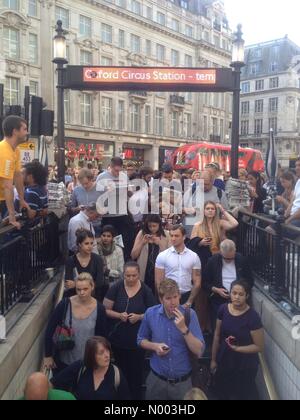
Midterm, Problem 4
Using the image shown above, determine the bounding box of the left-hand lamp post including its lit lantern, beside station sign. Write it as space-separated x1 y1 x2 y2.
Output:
53 20 68 182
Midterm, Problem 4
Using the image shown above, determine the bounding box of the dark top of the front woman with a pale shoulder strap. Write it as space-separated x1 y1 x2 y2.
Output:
51 361 130 401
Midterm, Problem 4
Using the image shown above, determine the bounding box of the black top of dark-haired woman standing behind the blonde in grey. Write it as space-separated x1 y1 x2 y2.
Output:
65 254 104 288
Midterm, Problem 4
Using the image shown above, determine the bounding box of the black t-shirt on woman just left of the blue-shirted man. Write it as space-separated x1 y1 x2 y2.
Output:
106 280 156 350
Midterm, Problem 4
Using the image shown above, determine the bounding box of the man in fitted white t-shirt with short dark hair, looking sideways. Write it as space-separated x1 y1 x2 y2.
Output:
155 225 201 307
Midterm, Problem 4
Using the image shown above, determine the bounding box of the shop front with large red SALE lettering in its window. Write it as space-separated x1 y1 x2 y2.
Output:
66 138 115 170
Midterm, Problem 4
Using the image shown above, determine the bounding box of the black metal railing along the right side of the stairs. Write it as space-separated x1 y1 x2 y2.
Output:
237 210 300 316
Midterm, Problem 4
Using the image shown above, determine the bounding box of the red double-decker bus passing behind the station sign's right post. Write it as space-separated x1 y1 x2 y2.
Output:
170 142 265 172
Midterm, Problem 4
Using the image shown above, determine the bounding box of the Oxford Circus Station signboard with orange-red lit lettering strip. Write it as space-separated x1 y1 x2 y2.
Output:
64 66 234 92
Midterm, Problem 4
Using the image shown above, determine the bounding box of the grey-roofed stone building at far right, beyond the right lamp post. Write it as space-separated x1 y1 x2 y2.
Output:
240 37 300 168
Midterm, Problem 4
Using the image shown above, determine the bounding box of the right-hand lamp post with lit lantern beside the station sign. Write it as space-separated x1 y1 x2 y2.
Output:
230 25 245 179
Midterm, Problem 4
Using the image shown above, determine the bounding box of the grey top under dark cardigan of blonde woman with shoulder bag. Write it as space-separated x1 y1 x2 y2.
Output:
59 305 97 366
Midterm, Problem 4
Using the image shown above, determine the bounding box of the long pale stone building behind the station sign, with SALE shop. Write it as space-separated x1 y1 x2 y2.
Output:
0 0 232 168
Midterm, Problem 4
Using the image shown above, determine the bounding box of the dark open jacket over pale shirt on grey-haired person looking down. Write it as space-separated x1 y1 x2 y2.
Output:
203 253 254 294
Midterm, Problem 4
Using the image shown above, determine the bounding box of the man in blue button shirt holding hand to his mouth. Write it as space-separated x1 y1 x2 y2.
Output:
137 280 205 401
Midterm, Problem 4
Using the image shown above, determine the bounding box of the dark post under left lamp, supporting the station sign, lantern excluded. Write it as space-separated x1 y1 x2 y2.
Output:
57 63 65 182
